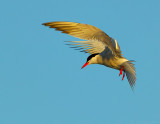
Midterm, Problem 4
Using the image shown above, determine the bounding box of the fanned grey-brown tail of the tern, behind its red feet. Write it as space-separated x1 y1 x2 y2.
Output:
123 61 136 89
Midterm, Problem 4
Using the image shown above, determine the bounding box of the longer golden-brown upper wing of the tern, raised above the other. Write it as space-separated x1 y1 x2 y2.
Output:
43 22 121 56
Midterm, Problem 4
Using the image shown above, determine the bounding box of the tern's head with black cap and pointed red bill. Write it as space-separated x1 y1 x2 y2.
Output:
81 53 99 69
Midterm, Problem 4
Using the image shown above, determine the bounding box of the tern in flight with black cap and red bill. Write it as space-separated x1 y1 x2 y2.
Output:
43 21 136 89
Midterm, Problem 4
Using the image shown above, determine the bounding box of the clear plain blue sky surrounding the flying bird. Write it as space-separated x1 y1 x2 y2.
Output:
0 0 160 124
